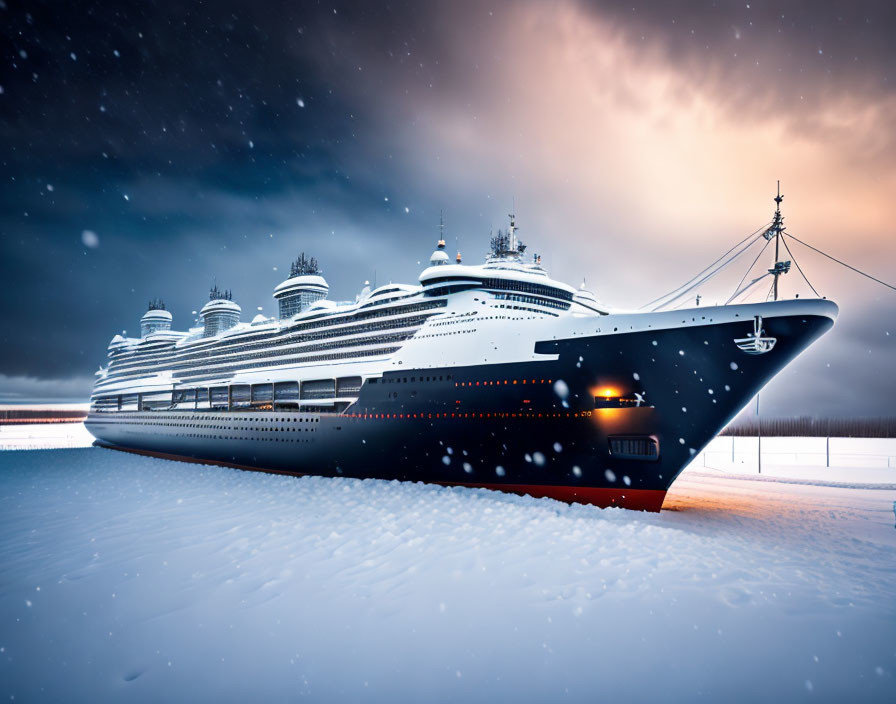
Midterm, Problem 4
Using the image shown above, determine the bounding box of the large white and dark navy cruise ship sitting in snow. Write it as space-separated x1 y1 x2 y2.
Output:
86 206 837 511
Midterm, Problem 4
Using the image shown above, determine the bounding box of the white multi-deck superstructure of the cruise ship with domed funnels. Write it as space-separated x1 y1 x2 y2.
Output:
92 222 607 410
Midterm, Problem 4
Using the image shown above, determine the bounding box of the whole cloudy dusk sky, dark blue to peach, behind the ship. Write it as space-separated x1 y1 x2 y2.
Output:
0 0 896 416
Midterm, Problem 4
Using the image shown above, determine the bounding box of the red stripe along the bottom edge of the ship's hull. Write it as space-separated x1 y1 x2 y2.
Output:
97 443 666 511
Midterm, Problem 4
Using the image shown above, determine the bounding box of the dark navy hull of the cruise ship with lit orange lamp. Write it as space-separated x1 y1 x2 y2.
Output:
87 311 833 511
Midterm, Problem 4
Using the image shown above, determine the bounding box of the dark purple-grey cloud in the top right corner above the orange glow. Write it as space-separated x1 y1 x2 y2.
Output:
582 0 896 98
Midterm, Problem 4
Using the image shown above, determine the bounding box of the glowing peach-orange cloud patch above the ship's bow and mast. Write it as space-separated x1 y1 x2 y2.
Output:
338 2 896 305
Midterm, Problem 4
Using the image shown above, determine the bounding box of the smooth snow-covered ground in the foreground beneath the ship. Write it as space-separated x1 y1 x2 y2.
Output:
0 448 896 702
